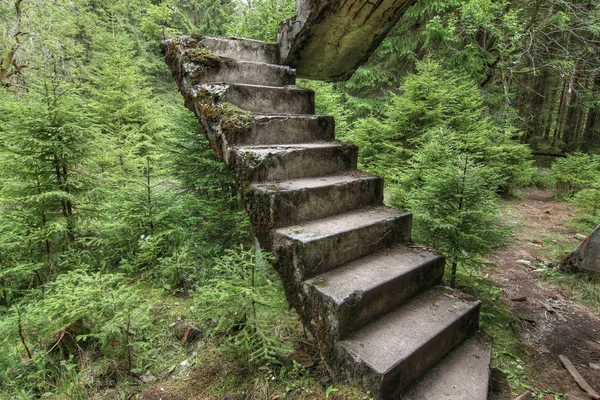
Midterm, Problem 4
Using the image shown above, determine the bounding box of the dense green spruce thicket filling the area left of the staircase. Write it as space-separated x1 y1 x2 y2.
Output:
0 0 258 399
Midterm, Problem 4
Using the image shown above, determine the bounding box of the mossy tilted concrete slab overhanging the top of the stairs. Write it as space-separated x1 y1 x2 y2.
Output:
278 0 415 82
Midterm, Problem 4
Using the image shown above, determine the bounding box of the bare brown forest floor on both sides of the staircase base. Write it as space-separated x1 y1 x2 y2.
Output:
137 188 600 400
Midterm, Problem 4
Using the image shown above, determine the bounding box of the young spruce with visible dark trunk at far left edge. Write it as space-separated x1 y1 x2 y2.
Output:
0 74 101 306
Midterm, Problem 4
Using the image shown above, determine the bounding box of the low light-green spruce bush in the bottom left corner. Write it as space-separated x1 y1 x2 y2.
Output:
0 270 154 394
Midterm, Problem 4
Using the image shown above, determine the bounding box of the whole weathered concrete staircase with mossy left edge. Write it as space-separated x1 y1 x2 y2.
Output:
163 36 491 400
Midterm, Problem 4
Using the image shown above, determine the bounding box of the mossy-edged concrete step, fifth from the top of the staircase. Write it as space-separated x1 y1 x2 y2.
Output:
227 142 358 183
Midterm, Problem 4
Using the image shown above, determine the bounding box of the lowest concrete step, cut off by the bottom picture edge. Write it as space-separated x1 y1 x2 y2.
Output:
402 336 492 400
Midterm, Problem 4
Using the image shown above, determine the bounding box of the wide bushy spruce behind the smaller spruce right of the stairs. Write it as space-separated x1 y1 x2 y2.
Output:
348 59 533 192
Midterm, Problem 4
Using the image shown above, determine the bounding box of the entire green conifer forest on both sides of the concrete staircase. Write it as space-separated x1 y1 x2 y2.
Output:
0 0 600 399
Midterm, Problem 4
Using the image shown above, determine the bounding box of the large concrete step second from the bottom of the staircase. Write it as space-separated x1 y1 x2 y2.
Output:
333 288 481 399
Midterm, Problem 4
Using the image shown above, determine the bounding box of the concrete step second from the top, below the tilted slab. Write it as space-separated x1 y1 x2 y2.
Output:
197 58 296 86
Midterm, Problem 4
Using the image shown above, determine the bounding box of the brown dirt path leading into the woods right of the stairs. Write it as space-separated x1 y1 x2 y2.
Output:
490 189 600 399
